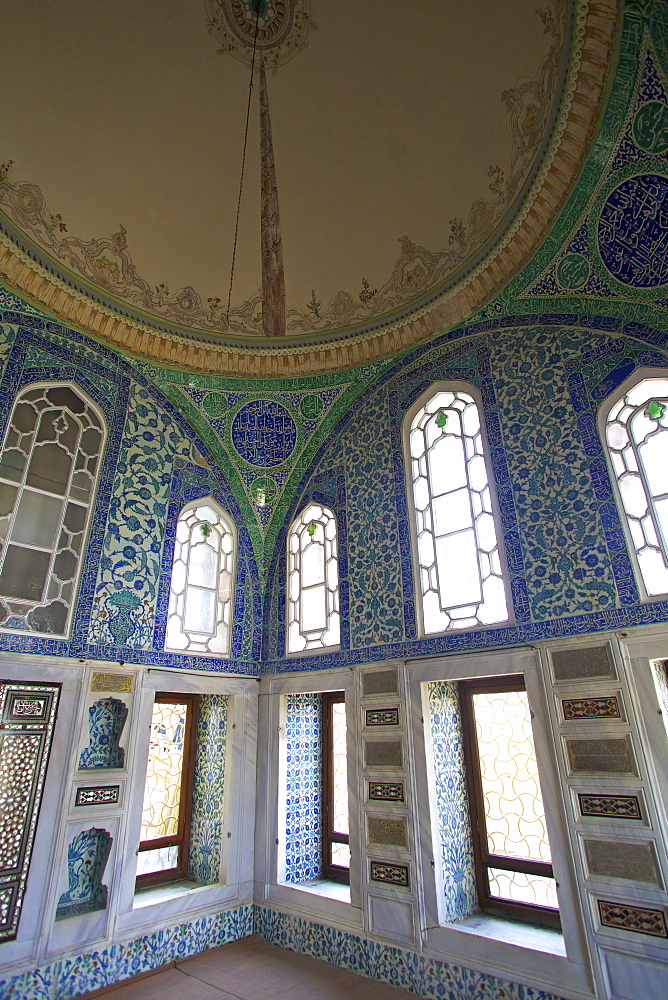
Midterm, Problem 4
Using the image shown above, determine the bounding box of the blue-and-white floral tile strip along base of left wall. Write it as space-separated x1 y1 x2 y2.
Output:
0 905 253 1000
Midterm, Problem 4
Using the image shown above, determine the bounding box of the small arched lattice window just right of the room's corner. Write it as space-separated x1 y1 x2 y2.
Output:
288 503 340 653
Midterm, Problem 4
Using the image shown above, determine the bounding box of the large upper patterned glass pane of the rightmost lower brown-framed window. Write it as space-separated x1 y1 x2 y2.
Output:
473 691 551 864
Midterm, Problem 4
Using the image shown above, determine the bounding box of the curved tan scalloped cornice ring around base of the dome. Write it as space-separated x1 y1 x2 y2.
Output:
0 0 621 378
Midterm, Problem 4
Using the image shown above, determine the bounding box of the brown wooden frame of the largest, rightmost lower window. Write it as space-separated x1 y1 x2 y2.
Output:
459 674 561 929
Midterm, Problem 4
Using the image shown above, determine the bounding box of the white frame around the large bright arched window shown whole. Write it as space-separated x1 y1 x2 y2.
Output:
402 379 514 638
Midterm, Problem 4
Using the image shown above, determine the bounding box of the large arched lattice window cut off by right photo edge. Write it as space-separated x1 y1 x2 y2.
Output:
605 378 668 597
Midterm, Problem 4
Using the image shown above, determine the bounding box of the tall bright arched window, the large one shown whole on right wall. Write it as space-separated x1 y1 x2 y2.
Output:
407 385 508 633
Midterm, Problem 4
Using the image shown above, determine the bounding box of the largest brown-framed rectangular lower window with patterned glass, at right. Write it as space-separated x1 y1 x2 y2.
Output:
459 675 559 927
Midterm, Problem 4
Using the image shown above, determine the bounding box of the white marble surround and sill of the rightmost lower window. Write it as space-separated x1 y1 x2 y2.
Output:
406 648 589 995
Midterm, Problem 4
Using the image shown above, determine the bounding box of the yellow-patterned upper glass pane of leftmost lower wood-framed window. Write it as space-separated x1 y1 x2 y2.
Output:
140 702 187 840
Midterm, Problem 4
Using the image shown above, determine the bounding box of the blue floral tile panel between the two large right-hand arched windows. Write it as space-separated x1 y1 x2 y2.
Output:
490 327 616 621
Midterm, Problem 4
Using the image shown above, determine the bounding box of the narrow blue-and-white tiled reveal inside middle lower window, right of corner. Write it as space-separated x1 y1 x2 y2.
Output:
285 694 322 882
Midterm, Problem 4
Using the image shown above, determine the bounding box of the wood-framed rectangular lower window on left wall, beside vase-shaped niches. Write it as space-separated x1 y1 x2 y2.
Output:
137 692 198 889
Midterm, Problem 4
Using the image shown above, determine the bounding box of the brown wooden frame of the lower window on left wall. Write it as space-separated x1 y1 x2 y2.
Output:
135 691 199 889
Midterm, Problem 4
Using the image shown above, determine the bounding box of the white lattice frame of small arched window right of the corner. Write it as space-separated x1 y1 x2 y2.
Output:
285 500 341 657
